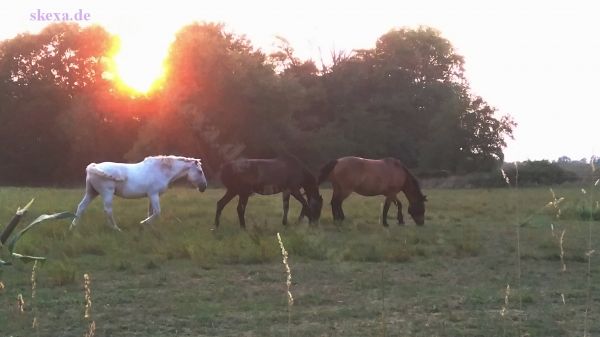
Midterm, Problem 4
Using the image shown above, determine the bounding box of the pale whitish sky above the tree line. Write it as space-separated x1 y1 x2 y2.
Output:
0 0 600 161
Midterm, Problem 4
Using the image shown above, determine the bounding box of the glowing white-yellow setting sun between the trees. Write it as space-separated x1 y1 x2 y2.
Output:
106 30 173 95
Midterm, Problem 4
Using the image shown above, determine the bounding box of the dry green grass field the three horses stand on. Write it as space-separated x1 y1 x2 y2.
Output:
0 187 600 337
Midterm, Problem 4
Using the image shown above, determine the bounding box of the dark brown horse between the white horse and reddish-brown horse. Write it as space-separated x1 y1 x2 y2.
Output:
215 157 323 228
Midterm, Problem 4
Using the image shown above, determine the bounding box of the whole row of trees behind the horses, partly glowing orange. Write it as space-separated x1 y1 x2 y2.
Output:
0 23 515 184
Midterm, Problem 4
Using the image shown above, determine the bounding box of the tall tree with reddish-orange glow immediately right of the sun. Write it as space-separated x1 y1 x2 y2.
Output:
130 23 302 167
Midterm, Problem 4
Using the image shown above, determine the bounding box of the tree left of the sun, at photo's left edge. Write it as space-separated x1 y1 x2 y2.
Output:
0 24 110 183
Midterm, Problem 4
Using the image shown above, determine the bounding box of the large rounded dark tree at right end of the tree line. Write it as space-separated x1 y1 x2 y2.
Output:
314 27 515 171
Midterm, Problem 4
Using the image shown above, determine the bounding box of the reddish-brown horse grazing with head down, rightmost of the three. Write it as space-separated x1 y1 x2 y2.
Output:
319 157 427 226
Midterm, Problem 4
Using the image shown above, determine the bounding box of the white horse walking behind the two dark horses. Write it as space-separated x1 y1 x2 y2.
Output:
70 156 206 231
